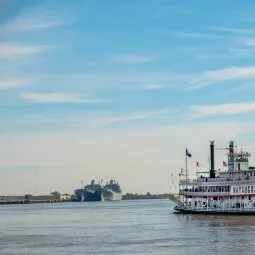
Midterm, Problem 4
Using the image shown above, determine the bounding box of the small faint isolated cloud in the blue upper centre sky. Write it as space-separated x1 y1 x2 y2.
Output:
109 55 155 64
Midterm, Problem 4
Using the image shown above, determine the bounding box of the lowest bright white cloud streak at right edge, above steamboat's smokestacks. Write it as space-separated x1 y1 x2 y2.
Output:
188 102 255 118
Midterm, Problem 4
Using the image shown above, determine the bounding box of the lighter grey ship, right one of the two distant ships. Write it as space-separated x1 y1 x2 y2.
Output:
102 180 122 201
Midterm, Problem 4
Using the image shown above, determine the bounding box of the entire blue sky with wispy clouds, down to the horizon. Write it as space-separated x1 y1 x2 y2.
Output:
0 0 255 194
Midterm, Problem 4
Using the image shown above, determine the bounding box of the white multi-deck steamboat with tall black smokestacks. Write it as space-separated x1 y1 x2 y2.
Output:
174 141 255 215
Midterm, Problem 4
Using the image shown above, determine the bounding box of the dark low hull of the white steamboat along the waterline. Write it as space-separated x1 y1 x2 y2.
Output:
174 206 255 216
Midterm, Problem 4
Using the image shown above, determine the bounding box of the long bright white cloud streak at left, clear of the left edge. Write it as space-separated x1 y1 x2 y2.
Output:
20 93 106 104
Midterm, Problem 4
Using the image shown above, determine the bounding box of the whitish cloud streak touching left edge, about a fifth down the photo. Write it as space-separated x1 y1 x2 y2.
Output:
0 43 50 59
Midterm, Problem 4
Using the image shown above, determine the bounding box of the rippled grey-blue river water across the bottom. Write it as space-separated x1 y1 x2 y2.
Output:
0 200 255 255
